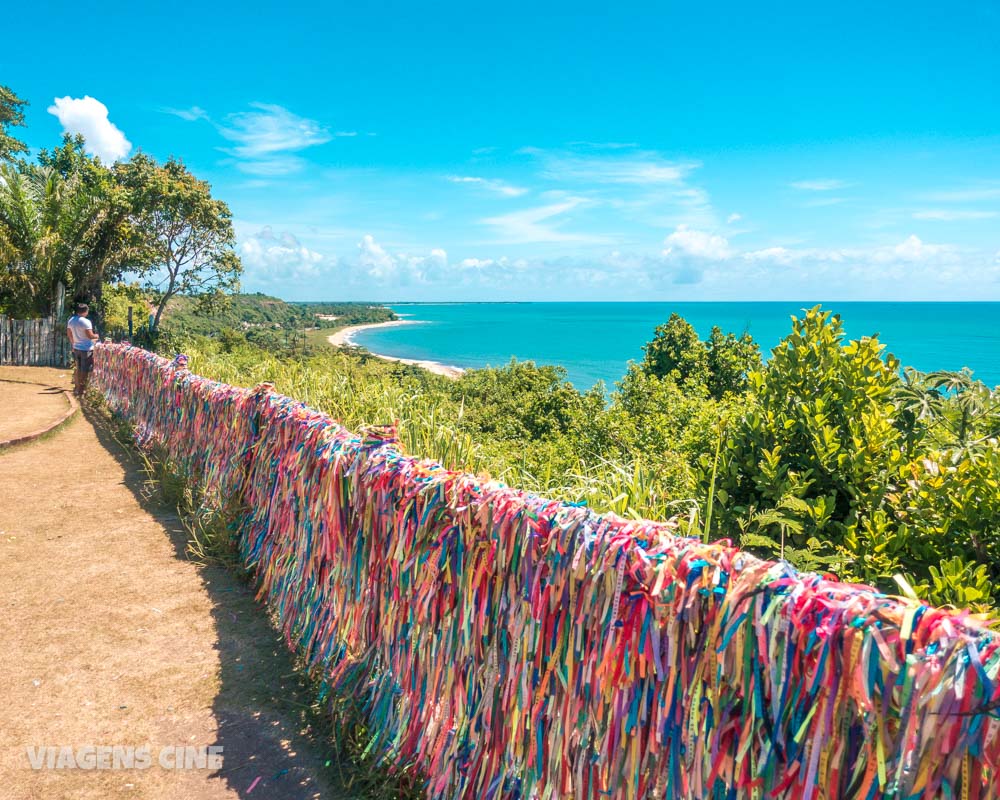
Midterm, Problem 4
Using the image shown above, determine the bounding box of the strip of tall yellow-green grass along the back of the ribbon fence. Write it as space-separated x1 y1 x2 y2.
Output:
186 342 700 527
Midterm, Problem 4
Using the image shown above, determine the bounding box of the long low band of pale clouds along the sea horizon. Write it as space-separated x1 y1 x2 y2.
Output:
232 228 1000 301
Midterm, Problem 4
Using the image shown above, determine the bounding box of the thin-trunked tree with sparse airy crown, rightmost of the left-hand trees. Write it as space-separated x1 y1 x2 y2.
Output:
121 154 242 329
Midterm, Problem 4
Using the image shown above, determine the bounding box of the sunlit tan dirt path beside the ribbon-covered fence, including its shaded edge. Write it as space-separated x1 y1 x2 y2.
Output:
0 368 350 800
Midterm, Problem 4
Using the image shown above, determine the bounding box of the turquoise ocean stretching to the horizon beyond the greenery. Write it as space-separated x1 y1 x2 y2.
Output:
354 302 1000 389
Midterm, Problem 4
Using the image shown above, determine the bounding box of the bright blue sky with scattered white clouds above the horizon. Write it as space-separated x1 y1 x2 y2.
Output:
0 0 1000 300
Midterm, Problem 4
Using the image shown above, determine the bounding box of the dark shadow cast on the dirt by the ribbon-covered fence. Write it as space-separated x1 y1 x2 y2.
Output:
84 408 382 800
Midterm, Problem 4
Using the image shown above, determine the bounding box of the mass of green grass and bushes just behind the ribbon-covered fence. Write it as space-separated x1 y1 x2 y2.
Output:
180 308 1000 610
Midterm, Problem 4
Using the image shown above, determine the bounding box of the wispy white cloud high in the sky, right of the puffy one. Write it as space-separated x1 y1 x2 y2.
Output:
219 103 333 175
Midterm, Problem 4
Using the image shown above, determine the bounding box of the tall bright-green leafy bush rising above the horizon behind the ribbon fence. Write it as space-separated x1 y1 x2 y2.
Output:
719 307 906 578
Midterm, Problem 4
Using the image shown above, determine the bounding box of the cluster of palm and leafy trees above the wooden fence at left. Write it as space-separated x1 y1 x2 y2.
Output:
0 130 242 326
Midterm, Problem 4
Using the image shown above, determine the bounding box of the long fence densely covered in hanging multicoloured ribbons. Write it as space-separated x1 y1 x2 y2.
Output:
95 345 1000 800
